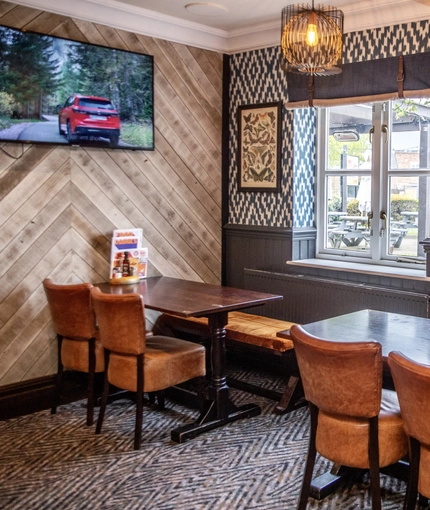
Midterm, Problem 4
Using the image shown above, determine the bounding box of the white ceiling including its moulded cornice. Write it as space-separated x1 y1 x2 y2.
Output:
15 0 430 53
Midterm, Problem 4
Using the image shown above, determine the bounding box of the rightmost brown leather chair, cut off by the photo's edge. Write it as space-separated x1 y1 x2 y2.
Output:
388 352 430 510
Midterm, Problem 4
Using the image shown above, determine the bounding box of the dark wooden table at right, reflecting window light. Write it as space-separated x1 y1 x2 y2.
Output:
278 310 430 499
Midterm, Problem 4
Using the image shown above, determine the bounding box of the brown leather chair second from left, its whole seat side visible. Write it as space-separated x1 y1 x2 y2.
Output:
91 287 206 450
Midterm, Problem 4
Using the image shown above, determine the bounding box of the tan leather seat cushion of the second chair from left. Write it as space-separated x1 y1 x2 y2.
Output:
108 336 206 392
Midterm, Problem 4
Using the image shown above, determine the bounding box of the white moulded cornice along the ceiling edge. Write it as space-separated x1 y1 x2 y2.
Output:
10 0 430 54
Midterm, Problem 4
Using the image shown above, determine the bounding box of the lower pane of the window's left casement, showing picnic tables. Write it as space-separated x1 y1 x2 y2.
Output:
325 175 370 253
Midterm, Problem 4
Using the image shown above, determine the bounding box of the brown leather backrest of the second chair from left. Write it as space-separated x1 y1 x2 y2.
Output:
91 287 146 355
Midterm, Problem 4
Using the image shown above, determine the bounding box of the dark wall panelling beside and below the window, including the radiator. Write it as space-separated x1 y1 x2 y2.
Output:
225 225 430 324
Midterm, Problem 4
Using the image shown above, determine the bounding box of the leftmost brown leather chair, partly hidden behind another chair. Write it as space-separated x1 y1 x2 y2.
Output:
43 278 104 425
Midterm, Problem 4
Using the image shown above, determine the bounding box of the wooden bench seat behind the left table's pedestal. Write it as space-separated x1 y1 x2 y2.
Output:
155 312 294 352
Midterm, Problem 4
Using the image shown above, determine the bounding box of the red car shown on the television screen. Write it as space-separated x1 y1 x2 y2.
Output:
58 94 120 147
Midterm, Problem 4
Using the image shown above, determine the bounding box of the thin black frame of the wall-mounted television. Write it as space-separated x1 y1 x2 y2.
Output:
0 24 155 151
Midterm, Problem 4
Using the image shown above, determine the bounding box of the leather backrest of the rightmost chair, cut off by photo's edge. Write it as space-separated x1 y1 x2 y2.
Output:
388 351 430 446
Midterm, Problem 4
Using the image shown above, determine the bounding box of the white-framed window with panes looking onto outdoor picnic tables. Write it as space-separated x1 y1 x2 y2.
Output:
317 100 430 269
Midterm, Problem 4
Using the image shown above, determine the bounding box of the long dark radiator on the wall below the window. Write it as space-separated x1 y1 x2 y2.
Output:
244 269 430 324
